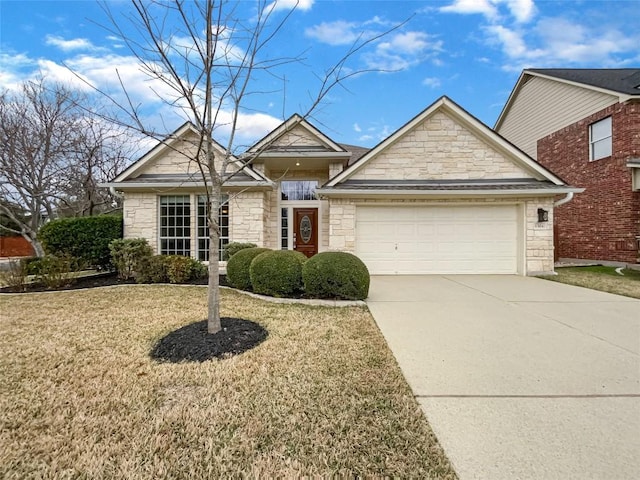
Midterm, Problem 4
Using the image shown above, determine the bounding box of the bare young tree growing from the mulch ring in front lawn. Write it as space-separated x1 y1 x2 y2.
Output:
97 0 397 333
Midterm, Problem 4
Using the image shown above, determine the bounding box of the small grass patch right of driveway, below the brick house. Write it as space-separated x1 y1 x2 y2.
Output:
542 265 640 298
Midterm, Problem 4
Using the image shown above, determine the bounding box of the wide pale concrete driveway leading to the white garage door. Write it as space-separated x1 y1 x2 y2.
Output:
367 275 640 479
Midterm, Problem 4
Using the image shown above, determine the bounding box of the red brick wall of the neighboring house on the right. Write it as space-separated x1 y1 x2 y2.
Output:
538 102 640 263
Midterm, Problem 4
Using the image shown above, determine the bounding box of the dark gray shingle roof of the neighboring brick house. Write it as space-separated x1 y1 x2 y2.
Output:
527 68 640 96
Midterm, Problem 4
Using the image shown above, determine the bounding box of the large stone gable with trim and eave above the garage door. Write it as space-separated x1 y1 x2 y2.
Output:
327 97 564 187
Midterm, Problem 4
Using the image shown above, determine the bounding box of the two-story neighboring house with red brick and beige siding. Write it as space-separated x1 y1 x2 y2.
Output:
495 68 640 263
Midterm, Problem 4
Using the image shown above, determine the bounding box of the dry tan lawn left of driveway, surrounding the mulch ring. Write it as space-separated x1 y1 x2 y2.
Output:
0 286 455 479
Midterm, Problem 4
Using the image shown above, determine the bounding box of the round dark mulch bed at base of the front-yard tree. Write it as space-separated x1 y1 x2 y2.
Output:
151 317 268 363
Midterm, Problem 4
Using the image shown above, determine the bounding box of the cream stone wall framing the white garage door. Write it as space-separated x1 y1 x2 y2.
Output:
329 198 554 275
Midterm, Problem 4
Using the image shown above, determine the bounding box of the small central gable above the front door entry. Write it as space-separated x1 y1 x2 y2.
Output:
247 113 346 154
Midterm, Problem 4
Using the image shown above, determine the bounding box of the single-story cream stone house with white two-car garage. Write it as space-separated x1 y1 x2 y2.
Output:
105 97 581 275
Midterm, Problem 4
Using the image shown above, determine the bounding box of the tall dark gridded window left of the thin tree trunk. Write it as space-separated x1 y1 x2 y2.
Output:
160 195 191 257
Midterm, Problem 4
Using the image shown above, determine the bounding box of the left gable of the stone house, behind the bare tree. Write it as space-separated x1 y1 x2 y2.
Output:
113 122 265 183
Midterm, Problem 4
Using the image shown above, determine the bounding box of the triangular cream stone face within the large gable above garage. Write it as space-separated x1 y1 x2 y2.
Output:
350 112 531 180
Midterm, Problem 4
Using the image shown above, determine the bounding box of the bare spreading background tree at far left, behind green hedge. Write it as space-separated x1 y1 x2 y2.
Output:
0 77 132 256
